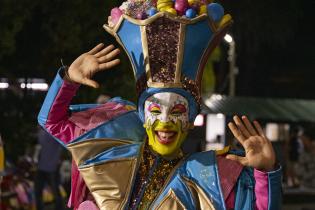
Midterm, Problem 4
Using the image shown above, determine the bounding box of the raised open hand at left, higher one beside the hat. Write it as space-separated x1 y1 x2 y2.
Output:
65 43 120 88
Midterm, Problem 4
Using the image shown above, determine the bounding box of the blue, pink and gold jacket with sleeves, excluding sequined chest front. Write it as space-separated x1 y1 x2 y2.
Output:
38 69 281 209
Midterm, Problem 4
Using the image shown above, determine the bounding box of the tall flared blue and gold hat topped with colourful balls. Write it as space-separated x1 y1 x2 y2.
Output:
104 0 232 122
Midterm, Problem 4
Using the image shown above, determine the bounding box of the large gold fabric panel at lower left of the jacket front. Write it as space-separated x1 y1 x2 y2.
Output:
79 158 137 210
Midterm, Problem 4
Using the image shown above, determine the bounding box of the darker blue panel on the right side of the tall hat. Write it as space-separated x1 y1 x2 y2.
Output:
182 19 213 80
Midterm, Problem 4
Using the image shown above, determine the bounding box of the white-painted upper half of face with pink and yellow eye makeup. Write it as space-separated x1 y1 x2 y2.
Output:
144 92 189 130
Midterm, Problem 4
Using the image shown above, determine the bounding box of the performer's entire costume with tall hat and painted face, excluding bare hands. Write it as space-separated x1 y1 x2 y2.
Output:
38 0 281 209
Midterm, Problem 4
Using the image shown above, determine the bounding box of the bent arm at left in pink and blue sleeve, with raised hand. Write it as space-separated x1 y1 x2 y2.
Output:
38 44 119 144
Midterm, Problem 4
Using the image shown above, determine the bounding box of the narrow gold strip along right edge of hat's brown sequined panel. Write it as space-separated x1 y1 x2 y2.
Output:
174 23 186 83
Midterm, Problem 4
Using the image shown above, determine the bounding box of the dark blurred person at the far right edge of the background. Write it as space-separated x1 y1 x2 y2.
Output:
296 128 315 188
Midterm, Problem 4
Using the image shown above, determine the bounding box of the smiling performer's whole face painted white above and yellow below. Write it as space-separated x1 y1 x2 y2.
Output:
144 92 189 156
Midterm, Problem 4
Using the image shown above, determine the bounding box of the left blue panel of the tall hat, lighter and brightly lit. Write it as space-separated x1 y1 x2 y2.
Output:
117 19 145 79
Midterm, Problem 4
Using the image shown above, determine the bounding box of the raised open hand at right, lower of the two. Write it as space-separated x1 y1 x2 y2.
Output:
226 116 276 171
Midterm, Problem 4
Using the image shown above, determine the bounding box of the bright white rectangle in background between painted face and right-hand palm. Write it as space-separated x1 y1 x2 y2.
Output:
206 114 225 150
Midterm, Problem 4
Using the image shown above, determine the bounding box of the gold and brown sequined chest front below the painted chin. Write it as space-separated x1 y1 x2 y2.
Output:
129 144 182 209
